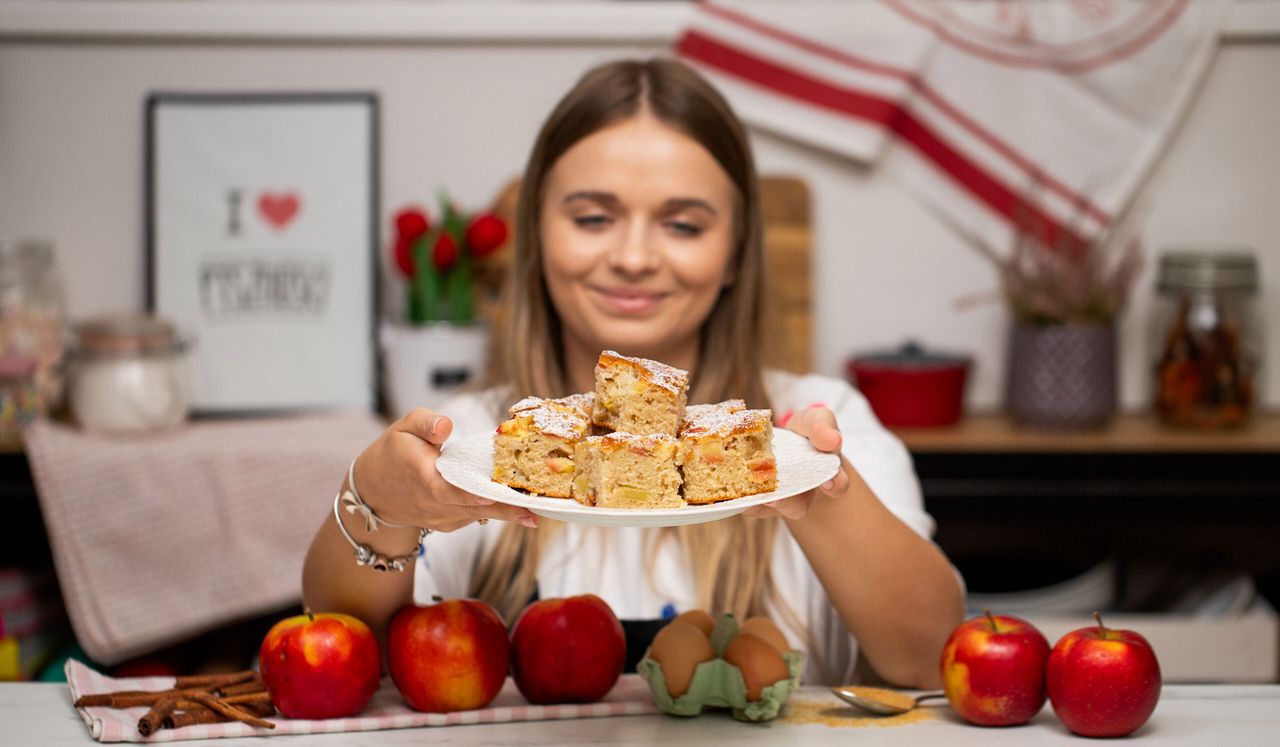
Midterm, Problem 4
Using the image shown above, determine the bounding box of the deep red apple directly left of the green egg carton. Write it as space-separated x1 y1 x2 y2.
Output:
511 594 627 704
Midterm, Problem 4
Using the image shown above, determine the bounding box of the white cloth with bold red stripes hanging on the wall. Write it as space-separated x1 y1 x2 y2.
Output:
676 0 1226 246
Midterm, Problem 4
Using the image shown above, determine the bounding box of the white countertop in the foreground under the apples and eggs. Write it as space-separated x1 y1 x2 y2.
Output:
0 683 1280 747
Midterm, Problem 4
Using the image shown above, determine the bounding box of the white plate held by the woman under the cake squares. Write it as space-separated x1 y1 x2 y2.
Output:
435 429 840 527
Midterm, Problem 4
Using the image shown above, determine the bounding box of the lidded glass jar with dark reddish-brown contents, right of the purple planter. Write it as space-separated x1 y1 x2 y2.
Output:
1152 249 1263 429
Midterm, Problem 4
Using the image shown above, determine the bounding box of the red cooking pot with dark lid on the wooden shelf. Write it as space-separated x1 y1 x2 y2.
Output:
846 342 970 426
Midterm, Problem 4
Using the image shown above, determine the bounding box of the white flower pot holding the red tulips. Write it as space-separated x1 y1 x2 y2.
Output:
379 322 489 417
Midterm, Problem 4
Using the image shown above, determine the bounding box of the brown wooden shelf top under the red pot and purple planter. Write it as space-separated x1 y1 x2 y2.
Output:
893 413 1280 453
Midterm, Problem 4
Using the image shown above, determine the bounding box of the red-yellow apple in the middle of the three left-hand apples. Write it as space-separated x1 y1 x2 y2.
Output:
387 597 511 712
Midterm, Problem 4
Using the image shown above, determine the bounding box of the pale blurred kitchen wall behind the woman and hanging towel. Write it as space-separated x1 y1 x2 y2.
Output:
0 0 1280 408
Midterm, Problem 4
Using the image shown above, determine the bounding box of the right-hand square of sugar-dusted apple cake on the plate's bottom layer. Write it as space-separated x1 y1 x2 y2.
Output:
680 400 778 504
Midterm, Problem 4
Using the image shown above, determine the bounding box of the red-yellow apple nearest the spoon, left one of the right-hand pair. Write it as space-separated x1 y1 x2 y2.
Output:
942 610 1048 727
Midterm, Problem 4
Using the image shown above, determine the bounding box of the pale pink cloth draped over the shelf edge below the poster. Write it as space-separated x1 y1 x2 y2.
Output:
26 412 385 664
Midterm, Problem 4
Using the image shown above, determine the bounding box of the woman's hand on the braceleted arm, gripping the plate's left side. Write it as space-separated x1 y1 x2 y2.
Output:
356 408 538 532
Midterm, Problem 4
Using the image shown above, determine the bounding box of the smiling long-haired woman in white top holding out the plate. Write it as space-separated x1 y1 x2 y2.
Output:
303 60 963 687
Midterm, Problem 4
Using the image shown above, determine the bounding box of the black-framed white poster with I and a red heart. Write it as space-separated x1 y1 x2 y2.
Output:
146 93 379 413
